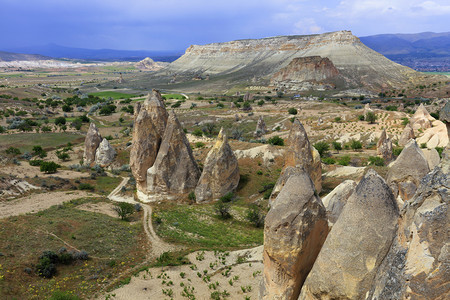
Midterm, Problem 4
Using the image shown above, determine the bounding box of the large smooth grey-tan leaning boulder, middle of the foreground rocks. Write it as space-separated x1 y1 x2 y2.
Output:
299 170 399 300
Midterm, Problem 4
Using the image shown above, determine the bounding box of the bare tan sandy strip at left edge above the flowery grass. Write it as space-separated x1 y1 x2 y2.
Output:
0 191 97 219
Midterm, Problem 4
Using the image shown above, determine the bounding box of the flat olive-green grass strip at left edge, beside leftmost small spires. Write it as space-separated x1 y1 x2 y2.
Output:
0 132 84 153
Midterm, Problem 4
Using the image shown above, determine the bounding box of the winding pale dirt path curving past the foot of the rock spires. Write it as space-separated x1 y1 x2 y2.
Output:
108 177 181 258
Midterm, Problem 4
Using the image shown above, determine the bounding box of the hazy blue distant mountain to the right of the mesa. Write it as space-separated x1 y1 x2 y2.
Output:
360 32 450 72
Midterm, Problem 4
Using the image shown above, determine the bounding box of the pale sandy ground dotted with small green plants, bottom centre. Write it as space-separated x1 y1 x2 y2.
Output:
109 246 263 300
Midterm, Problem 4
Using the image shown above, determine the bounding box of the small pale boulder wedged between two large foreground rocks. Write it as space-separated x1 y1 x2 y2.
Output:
322 180 356 224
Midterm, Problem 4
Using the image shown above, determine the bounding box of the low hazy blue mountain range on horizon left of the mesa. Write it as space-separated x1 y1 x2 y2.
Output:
3 44 182 62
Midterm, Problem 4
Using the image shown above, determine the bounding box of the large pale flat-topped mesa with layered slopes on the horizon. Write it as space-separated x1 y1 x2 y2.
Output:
164 31 430 89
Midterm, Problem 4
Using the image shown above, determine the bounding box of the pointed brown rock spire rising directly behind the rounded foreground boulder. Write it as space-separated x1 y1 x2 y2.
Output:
270 119 322 203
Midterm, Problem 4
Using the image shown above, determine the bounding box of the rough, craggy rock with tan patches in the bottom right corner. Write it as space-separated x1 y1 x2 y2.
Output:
366 167 450 300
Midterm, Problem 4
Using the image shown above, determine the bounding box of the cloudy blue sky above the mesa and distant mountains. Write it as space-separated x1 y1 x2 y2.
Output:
0 0 450 50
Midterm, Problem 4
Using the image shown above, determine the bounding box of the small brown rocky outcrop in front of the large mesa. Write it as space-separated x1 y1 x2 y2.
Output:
271 56 339 85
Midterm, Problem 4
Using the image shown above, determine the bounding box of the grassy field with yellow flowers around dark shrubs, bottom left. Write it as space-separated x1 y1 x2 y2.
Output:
0 198 146 299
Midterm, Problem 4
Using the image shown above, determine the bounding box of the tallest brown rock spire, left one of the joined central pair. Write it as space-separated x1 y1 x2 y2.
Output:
130 90 168 193
